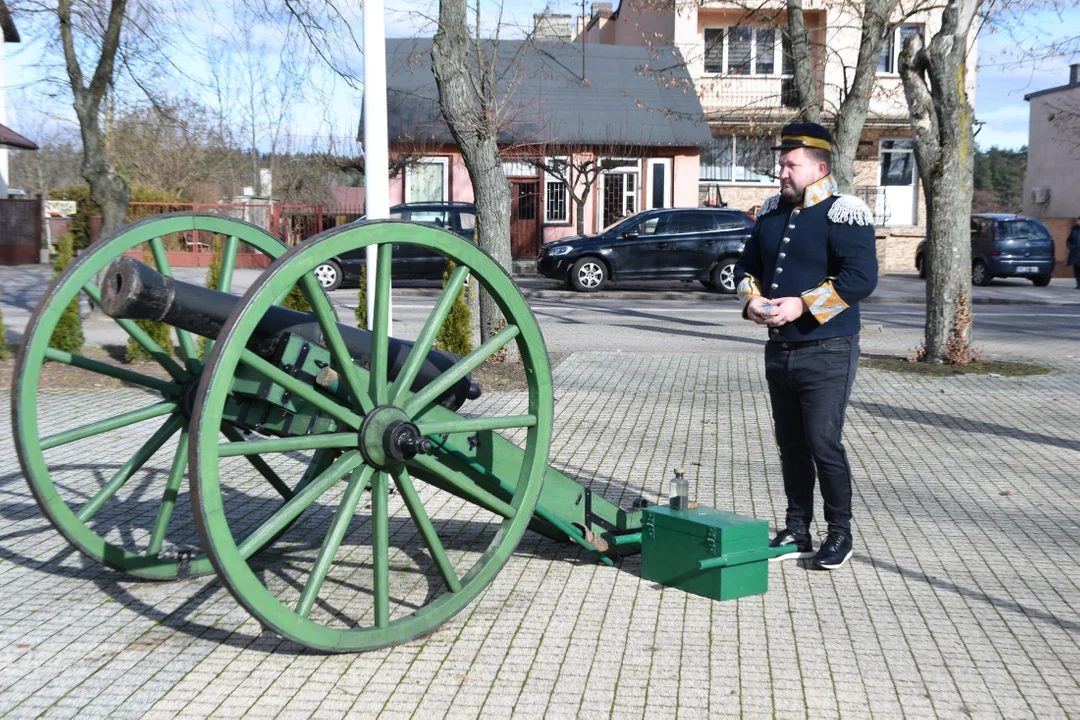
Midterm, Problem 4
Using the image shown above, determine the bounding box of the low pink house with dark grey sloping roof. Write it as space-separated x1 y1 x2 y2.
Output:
375 38 711 258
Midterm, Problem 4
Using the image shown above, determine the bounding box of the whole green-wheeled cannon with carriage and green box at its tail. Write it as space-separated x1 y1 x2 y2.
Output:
12 214 793 652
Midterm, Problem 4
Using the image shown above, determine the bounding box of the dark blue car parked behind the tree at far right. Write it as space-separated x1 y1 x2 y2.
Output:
915 213 1054 287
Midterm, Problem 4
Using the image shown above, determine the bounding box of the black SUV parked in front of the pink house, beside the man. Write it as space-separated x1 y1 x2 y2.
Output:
537 207 754 294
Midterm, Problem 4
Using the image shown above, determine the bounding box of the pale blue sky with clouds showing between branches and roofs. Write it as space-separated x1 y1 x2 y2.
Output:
5 0 1080 149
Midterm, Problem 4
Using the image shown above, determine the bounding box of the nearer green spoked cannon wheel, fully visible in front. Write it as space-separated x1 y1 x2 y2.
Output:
192 221 553 652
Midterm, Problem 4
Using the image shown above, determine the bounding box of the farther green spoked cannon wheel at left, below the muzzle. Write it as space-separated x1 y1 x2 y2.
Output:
12 213 302 580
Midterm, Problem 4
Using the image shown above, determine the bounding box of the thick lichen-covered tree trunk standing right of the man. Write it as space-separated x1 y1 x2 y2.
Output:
900 0 980 363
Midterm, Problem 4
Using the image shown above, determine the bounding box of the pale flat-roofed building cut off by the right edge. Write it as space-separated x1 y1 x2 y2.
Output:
1023 64 1080 277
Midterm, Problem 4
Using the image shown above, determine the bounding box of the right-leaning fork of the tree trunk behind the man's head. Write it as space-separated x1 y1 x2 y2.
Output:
825 0 896 194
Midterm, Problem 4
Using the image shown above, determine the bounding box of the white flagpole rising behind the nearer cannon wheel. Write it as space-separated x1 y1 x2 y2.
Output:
364 0 393 336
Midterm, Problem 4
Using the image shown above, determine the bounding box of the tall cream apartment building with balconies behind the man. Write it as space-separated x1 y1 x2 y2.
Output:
576 0 975 270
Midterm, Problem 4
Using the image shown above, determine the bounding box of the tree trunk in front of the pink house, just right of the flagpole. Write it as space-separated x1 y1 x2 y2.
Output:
431 0 516 358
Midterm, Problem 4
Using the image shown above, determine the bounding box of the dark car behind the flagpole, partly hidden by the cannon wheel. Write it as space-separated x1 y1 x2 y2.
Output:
315 202 476 290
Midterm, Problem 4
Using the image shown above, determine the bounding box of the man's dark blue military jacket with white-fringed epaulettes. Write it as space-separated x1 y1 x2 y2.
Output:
734 176 877 342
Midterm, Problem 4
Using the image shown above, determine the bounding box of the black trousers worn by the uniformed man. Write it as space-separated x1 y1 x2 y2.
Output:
765 335 859 533
